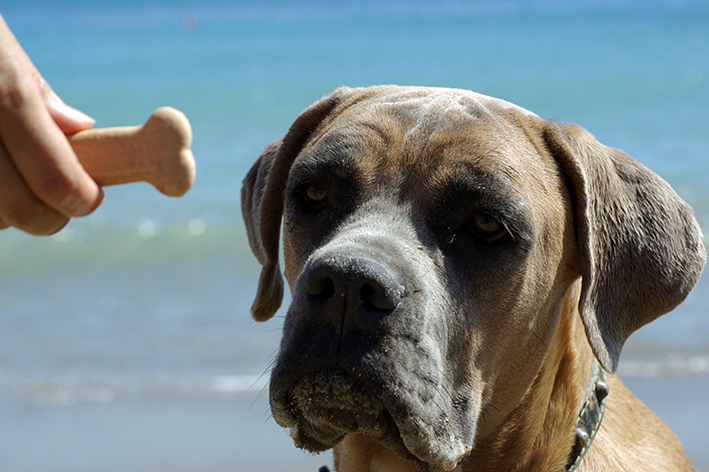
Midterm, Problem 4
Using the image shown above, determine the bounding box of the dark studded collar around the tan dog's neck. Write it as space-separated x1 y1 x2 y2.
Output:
563 359 609 472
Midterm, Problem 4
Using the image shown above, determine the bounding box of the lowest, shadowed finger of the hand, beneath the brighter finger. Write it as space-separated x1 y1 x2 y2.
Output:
0 141 69 235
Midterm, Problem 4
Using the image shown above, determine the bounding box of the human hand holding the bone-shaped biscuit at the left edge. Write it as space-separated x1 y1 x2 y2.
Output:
0 15 104 235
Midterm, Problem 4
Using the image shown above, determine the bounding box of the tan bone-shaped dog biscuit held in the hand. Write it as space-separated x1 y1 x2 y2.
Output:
69 107 195 197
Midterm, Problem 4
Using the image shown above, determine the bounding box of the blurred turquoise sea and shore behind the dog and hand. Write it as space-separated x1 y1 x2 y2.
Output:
0 0 709 472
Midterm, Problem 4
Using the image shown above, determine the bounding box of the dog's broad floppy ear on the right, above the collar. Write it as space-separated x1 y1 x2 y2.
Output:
543 121 706 372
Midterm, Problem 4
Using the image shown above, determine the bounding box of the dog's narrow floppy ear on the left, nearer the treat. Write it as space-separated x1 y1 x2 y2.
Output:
241 87 368 321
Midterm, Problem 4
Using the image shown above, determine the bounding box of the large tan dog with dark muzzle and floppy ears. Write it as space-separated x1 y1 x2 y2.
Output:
242 86 706 472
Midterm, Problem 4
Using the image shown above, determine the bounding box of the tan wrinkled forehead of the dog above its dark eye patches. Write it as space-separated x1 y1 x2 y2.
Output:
295 87 548 197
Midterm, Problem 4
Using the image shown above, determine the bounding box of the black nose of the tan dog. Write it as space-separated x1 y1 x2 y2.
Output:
303 255 404 328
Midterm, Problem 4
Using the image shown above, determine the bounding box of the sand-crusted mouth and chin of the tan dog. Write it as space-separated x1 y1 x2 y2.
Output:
271 369 464 471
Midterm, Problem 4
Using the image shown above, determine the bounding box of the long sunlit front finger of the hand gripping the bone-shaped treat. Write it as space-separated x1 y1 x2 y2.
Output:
0 19 102 216
